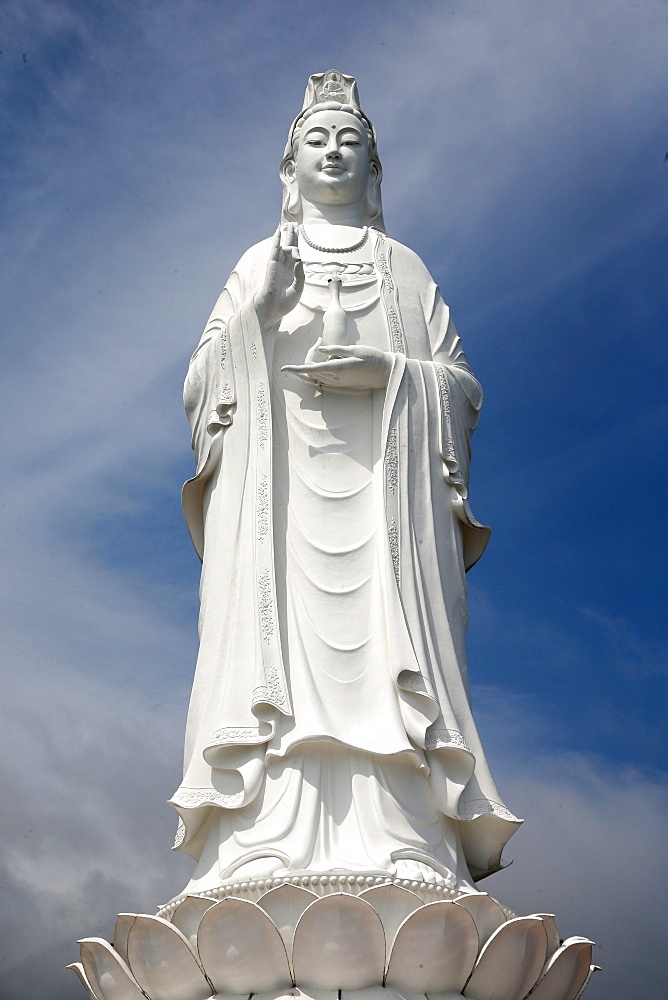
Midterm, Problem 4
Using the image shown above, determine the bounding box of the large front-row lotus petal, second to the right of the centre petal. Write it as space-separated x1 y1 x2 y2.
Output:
463 917 547 1000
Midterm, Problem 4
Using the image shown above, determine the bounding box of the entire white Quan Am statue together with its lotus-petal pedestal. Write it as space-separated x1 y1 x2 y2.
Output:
71 70 593 1000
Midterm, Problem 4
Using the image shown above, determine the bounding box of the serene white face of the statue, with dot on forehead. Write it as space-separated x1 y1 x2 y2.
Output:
295 111 375 205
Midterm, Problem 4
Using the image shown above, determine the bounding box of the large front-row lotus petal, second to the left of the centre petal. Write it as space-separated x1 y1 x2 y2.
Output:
128 915 213 1000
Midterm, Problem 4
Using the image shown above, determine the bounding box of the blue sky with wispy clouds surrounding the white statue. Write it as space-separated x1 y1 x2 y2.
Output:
0 0 668 1000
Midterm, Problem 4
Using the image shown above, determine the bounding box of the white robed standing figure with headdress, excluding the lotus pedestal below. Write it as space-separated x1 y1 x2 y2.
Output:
172 71 520 893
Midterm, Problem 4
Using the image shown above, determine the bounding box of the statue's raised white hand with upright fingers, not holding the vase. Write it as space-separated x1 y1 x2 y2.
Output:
253 222 304 330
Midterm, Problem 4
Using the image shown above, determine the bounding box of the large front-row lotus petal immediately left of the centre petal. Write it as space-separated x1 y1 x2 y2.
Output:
197 897 292 995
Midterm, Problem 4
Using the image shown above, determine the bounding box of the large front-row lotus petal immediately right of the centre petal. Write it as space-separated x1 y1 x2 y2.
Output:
385 900 479 994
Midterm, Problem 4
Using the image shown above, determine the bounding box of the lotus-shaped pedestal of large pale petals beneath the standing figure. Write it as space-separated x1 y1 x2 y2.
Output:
73 884 592 1000
